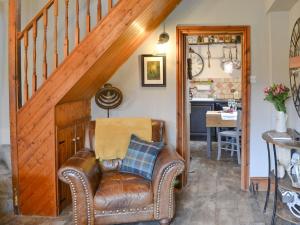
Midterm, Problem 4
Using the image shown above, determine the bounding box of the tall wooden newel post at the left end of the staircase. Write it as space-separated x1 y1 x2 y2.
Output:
8 0 22 214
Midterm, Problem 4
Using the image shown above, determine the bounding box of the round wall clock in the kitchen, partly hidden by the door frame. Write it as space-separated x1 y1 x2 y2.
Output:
187 48 204 80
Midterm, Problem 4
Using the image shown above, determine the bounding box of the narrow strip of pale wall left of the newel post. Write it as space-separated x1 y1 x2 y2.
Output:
0 0 10 144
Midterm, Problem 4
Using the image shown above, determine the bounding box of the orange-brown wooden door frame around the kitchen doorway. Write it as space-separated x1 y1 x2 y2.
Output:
176 25 251 190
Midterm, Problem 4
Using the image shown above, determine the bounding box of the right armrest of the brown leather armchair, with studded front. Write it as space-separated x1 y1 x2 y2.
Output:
152 147 184 220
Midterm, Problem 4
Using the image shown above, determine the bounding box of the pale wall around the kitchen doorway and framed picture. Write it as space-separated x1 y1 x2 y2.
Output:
92 0 271 176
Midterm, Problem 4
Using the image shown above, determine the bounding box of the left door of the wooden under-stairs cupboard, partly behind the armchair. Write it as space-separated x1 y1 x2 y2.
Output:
57 126 75 210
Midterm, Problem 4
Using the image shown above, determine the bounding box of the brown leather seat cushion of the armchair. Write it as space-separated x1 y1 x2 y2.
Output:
94 172 153 211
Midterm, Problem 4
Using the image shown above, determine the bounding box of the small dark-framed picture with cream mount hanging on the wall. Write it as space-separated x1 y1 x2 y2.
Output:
141 55 166 87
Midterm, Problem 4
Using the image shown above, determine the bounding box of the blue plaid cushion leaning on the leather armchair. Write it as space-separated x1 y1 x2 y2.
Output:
120 134 164 180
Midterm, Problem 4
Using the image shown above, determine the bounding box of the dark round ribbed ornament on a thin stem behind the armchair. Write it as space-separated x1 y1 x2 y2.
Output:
95 83 123 118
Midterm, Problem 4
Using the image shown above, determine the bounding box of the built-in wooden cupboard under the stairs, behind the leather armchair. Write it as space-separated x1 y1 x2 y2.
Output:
55 100 91 213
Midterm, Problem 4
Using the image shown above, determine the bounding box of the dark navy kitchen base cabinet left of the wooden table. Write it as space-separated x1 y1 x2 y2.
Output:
190 103 214 140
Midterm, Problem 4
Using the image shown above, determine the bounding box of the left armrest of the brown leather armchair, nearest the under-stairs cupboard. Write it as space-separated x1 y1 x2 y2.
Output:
58 149 101 224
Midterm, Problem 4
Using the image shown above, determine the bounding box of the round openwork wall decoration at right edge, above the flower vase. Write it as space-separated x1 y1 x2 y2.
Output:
289 18 300 117
